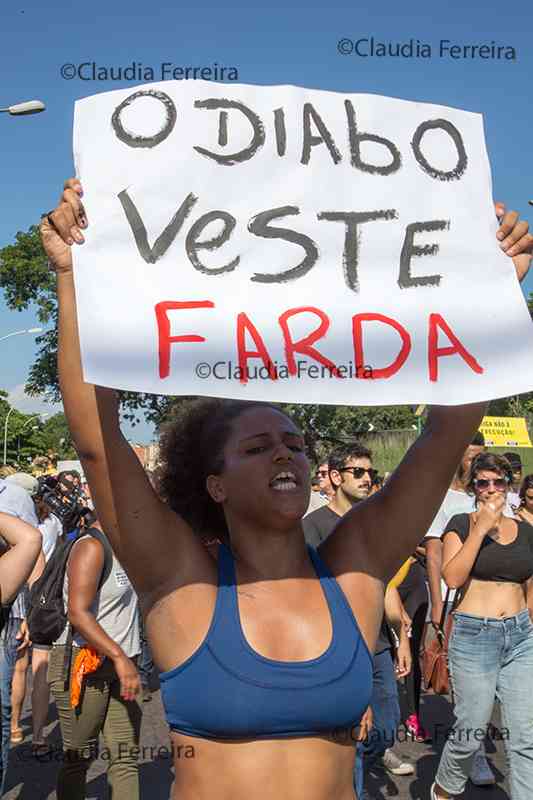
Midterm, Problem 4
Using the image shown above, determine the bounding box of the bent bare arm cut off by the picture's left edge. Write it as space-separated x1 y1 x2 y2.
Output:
0 512 42 603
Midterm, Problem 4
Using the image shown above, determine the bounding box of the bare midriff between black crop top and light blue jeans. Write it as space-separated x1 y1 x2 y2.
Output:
455 578 526 619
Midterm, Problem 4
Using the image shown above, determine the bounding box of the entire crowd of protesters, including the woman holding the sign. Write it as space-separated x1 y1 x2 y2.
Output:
0 180 533 800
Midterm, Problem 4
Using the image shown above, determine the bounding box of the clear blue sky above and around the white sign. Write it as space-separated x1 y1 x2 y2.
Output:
0 0 533 441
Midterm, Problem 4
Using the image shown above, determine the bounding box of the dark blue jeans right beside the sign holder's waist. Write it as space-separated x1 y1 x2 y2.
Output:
354 650 400 800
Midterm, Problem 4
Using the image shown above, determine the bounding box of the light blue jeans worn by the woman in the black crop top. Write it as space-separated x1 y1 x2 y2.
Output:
435 608 533 800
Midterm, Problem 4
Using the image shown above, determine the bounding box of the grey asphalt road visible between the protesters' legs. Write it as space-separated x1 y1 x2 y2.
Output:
3 676 510 800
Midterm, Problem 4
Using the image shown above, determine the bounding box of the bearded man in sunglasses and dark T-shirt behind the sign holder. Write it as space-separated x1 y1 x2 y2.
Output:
303 442 414 800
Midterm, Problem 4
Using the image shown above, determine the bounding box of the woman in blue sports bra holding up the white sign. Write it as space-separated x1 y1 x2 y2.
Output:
41 180 533 800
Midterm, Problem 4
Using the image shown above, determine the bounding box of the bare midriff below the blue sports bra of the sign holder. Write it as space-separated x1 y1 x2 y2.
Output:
166 728 355 800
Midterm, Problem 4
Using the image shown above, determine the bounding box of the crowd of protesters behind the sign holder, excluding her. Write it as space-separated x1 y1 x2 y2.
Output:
0 433 533 800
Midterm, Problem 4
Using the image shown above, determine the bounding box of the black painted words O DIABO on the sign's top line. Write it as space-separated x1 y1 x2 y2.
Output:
111 89 468 181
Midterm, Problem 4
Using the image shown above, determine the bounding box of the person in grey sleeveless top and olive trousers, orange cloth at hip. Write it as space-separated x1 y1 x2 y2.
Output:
45 520 142 800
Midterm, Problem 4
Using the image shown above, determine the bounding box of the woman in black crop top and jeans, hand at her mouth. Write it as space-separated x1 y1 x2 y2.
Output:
432 453 533 800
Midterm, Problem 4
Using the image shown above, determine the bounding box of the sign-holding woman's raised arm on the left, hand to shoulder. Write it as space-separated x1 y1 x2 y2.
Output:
41 179 214 593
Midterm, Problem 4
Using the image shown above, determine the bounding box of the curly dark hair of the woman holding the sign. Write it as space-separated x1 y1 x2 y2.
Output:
158 398 290 541
